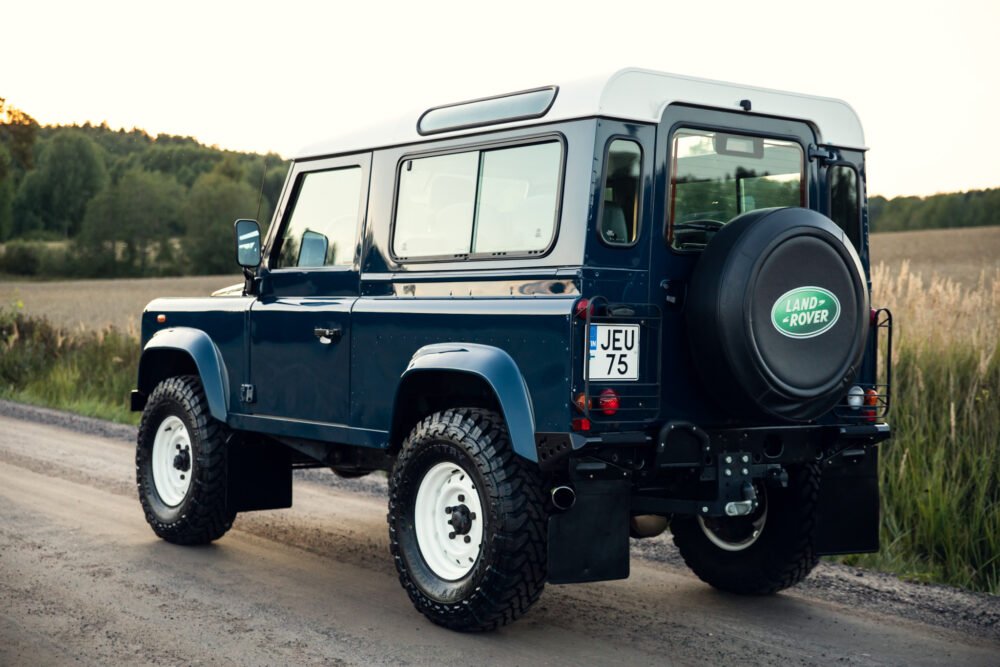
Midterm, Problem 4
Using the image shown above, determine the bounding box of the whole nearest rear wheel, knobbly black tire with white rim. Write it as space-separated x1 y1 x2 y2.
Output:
388 408 546 631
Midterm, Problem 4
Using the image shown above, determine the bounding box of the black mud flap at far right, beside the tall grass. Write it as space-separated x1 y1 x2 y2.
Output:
815 447 879 555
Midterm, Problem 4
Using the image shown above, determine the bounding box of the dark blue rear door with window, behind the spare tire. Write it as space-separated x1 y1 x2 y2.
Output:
650 104 822 422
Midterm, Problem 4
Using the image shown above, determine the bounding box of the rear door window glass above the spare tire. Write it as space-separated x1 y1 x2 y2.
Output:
669 128 805 250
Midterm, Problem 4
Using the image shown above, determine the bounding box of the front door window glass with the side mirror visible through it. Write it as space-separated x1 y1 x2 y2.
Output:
274 167 361 269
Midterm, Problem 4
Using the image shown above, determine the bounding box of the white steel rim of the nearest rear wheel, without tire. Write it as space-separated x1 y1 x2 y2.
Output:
413 462 483 581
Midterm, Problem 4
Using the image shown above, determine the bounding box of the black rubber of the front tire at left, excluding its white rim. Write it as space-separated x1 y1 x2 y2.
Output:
135 376 236 544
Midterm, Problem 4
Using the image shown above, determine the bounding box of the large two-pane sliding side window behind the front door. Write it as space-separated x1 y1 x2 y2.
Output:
392 141 562 259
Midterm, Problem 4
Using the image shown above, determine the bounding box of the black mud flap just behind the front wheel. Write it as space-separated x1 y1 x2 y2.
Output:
226 439 292 512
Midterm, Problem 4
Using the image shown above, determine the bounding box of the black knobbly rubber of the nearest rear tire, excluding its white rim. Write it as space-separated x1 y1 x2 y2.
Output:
388 408 547 632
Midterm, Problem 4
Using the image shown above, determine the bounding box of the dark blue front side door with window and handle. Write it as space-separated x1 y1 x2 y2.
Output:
246 153 371 426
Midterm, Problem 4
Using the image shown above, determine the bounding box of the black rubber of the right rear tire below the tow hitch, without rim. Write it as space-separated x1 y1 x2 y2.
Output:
670 464 820 595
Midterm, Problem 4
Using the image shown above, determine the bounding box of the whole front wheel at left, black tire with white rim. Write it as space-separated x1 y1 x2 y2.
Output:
135 376 236 544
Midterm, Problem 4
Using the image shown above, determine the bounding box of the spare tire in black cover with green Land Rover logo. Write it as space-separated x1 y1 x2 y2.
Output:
685 208 870 422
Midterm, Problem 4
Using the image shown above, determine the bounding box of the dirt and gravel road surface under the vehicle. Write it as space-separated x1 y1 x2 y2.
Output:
0 402 1000 666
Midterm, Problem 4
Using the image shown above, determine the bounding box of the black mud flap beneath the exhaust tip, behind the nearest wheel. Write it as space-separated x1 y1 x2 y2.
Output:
548 480 630 584
